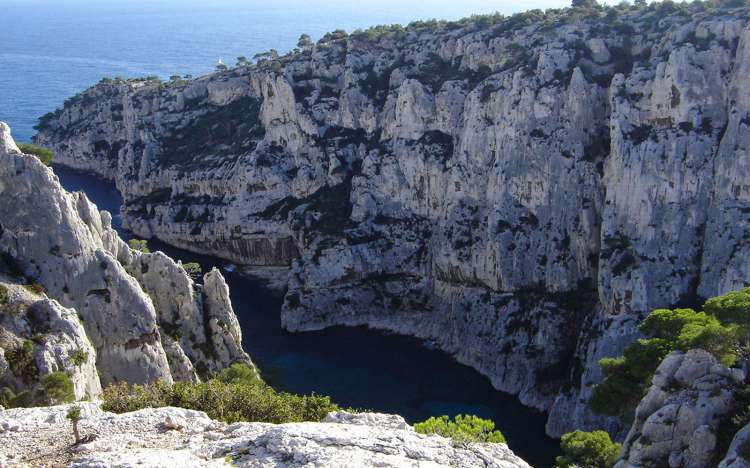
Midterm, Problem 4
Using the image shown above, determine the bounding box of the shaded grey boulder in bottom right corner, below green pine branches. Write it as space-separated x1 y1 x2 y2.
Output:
615 349 745 468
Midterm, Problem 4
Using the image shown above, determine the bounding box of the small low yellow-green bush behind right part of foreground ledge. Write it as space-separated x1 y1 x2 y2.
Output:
414 414 505 444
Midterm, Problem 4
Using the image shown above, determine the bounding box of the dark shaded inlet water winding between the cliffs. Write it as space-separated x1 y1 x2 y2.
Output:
55 167 559 467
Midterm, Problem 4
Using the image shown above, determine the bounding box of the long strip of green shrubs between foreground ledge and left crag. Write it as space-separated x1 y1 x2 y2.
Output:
102 365 339 423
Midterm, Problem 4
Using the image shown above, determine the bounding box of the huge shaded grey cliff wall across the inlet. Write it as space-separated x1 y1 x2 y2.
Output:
36 3 750 434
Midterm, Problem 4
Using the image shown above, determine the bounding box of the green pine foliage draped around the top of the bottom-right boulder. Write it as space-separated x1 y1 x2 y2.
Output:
590 288 750 420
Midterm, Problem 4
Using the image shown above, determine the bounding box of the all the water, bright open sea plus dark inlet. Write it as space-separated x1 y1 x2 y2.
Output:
0 0 565 467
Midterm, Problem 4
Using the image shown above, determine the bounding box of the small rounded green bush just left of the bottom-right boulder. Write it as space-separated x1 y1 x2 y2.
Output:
555 431 620 468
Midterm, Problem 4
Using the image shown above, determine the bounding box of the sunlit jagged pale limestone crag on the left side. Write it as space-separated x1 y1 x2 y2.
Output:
0 122 251 398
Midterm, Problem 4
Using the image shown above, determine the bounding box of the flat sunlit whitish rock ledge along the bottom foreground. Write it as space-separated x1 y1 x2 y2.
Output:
0 403 529 468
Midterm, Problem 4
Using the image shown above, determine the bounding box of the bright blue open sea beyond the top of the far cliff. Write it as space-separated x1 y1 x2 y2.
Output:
0 0 565 141
